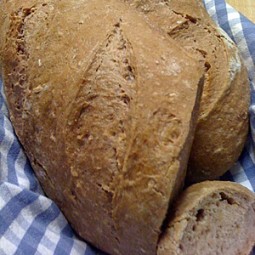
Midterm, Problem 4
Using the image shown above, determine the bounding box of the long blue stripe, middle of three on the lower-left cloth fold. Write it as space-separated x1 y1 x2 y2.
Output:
14 203 59 255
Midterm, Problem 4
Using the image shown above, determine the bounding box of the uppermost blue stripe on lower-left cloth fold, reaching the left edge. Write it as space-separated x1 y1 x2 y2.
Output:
0 190 38 236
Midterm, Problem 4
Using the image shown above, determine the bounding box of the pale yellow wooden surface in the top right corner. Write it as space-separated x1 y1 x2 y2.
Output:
226 0 255 22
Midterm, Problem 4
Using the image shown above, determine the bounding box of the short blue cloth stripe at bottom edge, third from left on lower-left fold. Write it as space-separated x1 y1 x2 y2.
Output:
54 224 74 255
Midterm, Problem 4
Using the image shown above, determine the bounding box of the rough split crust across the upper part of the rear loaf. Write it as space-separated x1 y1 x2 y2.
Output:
125 0 230 119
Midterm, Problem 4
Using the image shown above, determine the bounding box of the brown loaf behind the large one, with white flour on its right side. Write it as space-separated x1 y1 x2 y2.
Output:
126 0 250 182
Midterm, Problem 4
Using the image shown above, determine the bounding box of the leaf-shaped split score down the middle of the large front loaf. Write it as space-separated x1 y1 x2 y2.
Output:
66 20 137 207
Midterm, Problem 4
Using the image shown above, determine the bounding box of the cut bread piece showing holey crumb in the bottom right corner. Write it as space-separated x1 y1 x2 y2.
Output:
158 181 255 255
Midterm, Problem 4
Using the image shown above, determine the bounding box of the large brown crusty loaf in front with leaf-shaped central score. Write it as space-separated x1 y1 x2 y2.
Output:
0 0 203 255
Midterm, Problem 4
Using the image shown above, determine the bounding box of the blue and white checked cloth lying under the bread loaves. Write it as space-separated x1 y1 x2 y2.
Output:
0 0 255 255
